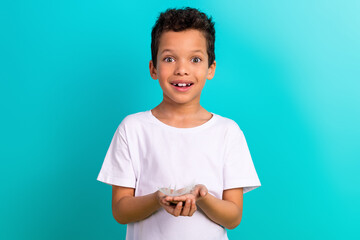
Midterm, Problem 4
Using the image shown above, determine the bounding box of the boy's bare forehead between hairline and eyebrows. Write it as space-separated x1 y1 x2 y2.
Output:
159 29 206 54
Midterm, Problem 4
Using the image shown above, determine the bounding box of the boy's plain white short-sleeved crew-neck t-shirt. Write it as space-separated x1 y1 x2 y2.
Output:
97 110 261 240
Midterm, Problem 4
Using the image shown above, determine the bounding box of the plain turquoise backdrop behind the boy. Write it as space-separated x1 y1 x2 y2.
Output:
0 0 360 239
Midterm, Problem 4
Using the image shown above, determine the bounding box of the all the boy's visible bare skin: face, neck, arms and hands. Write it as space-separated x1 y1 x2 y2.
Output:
112 29 243 229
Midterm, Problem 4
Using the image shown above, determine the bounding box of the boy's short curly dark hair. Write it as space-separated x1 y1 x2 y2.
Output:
151 7 215 68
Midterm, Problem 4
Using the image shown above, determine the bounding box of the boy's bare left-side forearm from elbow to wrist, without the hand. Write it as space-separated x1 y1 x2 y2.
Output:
112 192 160 224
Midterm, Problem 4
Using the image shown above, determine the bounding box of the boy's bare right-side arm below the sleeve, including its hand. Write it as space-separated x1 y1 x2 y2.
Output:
173 184 243 229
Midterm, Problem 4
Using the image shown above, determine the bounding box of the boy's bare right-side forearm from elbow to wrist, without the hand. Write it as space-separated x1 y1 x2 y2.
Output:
197 193 242 229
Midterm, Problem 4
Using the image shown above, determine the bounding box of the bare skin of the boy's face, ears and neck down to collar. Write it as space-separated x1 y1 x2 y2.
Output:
149 30 216 128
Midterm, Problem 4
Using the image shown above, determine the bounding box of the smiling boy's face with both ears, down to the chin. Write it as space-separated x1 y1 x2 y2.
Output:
149 29 216 105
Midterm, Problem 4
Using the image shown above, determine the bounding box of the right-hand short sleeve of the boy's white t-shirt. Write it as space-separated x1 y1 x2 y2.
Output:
223 122 261 193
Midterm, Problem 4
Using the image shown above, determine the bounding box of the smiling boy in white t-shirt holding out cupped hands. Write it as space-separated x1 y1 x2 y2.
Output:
98 8 260 240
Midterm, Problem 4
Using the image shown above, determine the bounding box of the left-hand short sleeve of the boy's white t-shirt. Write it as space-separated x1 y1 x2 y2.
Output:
97 124 136 188
